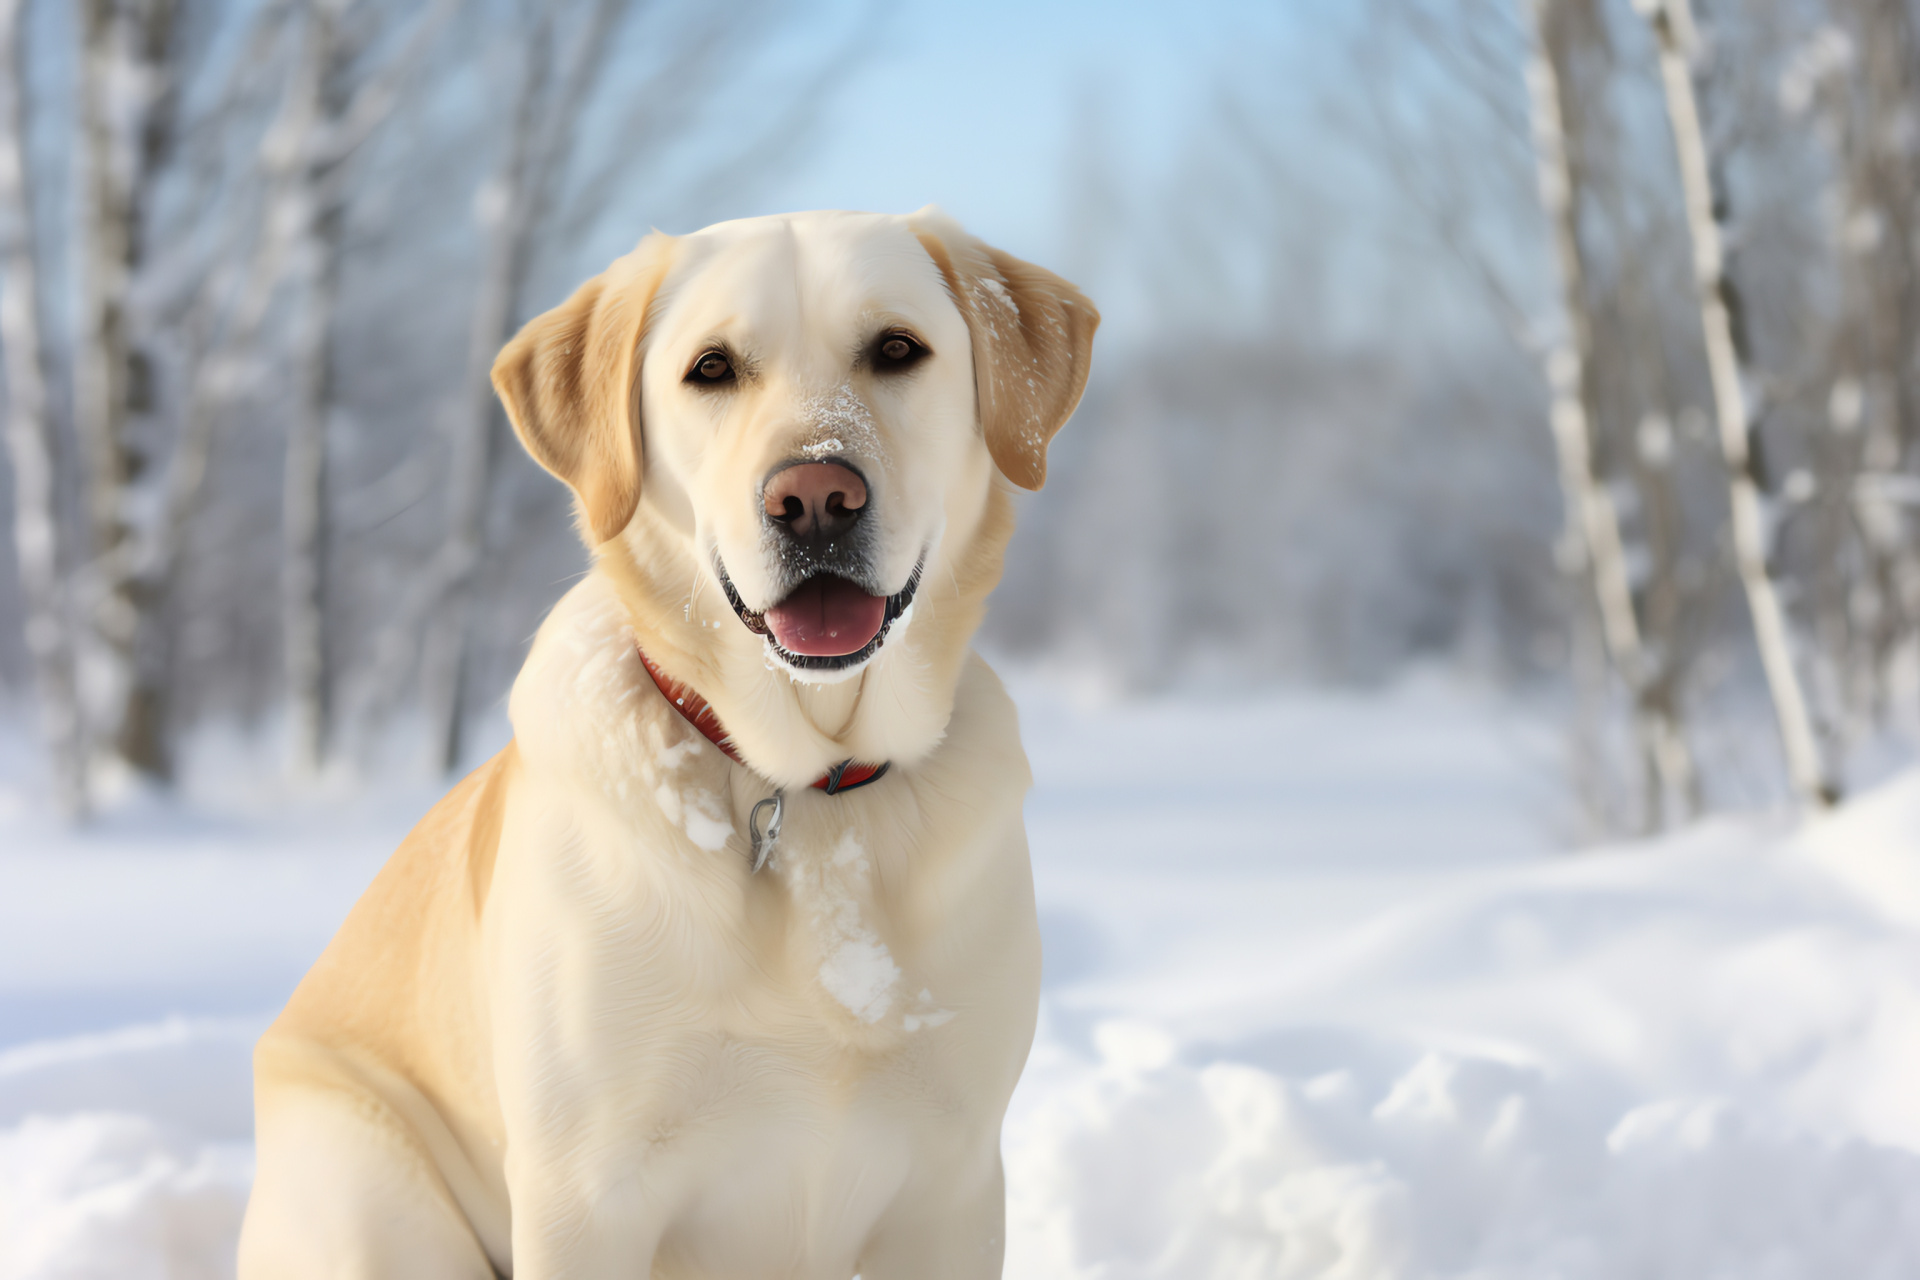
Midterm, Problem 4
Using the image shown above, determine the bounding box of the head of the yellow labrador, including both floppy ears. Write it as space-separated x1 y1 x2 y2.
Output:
493 209 1098 681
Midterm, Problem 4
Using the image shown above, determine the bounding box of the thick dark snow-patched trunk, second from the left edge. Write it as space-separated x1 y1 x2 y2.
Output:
73 0 175 779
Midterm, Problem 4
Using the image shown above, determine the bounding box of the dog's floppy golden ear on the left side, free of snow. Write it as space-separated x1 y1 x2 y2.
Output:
493 232 674 545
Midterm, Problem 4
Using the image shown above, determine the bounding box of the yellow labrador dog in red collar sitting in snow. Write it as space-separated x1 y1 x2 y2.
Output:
240 209 1100 1280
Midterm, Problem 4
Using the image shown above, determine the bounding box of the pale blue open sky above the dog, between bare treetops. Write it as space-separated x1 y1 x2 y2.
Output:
748 0 1304 257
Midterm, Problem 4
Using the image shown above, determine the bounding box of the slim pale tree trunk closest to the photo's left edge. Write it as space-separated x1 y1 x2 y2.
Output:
0 0 86 818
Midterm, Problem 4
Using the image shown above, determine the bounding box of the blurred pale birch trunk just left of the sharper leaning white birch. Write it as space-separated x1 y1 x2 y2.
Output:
1521 0 1693 831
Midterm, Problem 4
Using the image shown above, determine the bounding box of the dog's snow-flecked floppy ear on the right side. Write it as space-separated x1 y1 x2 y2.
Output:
912 205 1100 489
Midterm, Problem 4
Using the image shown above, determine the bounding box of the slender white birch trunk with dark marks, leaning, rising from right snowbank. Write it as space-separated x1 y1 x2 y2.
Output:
1636 0 1837 808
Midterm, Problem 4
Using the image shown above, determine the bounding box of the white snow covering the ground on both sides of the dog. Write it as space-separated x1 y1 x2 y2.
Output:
0 676 1920 1280
